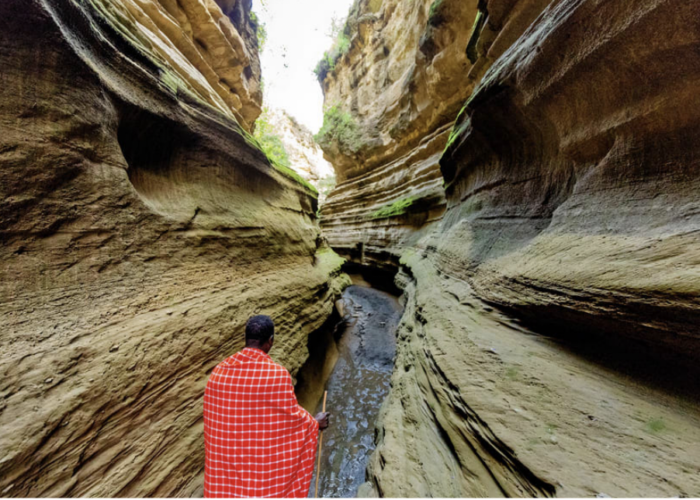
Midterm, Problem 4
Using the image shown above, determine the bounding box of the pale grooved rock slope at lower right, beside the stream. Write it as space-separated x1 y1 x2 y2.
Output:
364 254 700 498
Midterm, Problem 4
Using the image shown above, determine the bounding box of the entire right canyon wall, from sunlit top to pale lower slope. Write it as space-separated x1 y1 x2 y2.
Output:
322 0 700 497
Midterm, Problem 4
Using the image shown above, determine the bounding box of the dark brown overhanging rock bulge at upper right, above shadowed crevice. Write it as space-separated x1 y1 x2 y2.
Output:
440 1 700 358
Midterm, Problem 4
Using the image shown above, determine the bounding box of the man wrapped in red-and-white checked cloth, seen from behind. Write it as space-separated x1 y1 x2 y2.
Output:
204 316 329 498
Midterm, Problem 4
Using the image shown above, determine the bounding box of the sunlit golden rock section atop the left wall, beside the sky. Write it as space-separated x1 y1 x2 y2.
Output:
69 0 262 131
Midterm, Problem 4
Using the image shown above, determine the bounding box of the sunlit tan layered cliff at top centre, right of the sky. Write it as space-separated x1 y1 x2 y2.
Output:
322 0 546 271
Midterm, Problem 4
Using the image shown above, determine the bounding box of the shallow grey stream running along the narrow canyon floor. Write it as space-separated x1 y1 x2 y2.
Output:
309 277 401 498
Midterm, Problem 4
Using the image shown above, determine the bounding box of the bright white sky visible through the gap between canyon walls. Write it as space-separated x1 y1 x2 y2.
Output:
253 0 352 133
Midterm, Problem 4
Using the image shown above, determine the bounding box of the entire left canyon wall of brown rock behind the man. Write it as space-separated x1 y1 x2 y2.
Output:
0 0 344 497
